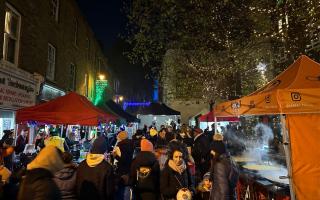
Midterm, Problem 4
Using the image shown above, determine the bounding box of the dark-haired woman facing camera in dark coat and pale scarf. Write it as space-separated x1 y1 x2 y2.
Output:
160 147 194 199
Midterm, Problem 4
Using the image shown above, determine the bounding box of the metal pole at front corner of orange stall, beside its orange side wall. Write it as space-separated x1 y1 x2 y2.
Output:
280 114 296 200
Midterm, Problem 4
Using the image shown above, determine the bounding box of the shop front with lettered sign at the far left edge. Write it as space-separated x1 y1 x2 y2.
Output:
0 62 37 138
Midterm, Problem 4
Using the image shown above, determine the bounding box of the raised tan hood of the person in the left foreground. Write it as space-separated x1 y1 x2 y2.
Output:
27 145 64 174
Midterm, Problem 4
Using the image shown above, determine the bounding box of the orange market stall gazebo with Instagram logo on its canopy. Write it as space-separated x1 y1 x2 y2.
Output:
215 56 320 200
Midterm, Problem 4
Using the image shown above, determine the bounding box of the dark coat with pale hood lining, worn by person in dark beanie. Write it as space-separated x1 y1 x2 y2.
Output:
76 155 114 200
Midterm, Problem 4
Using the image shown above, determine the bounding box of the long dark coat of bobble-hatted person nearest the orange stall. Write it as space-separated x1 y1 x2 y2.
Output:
210 154 235 200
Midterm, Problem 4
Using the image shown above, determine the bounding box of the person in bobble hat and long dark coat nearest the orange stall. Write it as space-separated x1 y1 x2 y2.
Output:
210 140 235 200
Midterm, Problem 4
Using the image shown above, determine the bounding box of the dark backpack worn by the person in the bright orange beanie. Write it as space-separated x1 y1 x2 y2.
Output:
135 166 156 191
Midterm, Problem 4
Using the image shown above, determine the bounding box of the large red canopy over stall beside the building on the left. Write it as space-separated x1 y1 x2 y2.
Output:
16 92 117 126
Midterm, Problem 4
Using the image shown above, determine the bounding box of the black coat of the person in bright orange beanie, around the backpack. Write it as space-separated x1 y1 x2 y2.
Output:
129 151 160 200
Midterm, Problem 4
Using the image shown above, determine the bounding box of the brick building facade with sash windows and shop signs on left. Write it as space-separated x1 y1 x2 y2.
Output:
0 0 113 134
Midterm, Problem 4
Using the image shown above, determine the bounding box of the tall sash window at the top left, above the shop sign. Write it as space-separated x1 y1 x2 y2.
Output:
3 4 21 66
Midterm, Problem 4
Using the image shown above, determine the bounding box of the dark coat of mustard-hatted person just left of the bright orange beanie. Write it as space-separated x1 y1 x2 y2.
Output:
115 139 134 176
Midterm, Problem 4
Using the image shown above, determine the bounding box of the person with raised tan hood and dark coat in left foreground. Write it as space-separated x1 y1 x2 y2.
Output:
18 146 63 200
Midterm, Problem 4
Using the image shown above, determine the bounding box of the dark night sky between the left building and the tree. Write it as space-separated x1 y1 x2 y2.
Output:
77 0 152 101
